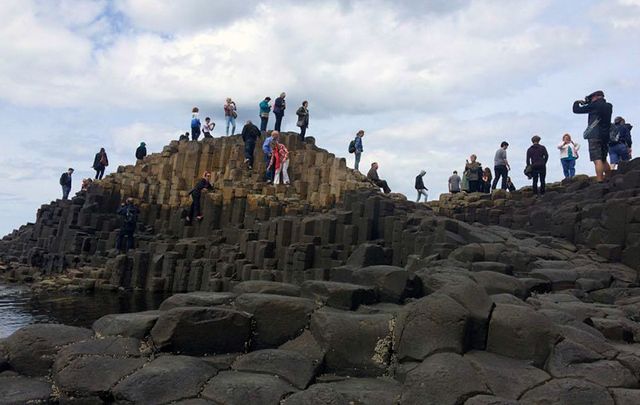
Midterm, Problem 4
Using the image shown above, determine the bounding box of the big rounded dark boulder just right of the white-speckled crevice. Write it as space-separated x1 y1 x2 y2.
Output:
394 293 469 360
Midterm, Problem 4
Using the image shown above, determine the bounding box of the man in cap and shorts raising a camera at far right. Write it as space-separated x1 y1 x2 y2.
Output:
573 90 613 183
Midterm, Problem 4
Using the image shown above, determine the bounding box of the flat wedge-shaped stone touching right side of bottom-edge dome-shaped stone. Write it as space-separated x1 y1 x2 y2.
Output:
464 351 551 400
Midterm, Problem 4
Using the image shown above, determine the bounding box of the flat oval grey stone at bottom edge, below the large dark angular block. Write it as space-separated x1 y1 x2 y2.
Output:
112 356 217 404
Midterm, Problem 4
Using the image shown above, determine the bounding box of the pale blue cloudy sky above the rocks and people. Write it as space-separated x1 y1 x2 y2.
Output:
0 0 640 235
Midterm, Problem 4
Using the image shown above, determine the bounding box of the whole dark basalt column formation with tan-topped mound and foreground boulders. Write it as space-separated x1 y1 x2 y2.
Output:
0 135 640 405
